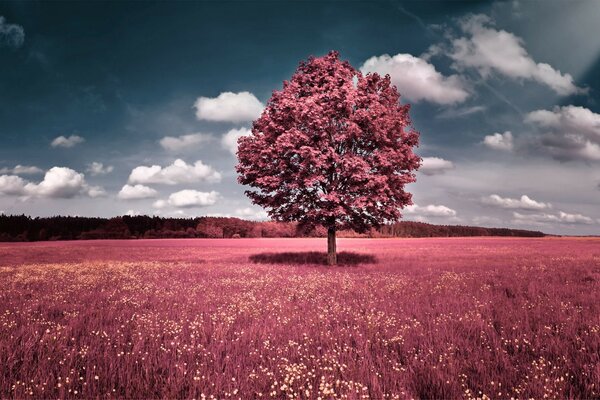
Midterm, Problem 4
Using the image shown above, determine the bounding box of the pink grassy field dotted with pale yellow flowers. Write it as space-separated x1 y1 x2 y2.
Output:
0 238 600 399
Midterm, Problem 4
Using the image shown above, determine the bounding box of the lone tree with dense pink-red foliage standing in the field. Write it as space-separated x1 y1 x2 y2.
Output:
236 51 421 265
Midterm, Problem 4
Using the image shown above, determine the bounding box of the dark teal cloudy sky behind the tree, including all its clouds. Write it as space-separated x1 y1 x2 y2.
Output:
0 0 600 234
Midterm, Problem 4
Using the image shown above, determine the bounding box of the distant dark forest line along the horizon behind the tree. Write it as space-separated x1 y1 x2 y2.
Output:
0 215 545 242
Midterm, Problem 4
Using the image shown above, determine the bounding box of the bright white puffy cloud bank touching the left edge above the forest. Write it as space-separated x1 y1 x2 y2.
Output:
0 167 105 199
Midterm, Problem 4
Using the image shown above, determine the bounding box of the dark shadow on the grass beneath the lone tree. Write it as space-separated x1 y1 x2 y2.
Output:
250 251 377 266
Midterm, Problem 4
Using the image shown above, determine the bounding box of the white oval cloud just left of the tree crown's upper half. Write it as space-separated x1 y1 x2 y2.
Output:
194 92 265 123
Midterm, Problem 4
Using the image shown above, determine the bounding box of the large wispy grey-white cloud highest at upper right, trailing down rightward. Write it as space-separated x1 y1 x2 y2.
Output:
448 14 586 96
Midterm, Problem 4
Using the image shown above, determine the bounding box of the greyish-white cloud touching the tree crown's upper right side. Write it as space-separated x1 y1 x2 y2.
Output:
360 54 469 104
